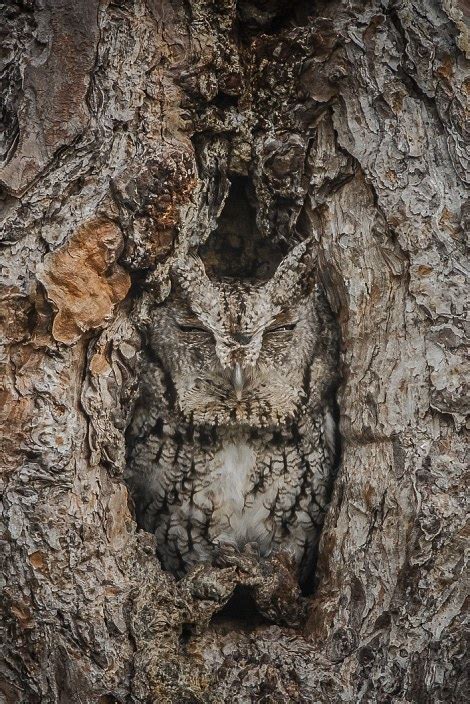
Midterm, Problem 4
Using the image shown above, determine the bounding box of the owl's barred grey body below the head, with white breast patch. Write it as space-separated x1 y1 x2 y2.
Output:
129 408 332 581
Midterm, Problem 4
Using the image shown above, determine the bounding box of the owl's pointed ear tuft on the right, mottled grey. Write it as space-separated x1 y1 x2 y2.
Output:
266 238 317 305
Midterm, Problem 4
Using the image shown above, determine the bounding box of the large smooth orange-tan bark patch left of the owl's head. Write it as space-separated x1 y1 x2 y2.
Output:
38 219 130 345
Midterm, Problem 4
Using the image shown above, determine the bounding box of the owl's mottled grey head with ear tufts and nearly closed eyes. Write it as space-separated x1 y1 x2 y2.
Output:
150 242 319 428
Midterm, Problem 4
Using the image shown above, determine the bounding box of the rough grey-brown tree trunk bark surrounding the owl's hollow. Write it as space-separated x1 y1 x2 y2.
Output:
0 0 470 704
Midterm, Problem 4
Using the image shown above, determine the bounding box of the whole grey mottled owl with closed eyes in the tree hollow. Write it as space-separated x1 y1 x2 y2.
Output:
127 243 336 581
